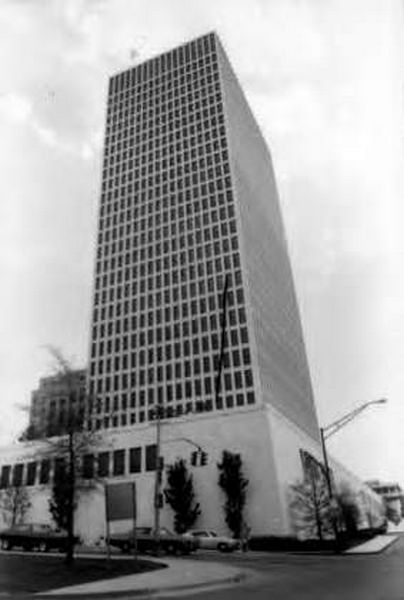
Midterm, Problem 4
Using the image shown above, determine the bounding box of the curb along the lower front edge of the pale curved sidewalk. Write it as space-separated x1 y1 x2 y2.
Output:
34 572 247 600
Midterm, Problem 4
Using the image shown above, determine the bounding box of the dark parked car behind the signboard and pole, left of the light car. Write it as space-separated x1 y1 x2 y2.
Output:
109 527 197 554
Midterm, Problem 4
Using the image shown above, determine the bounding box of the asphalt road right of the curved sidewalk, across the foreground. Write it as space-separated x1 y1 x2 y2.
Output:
176 536 404 600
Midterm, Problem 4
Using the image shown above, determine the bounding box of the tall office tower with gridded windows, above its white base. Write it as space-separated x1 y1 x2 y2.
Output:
89 33 318 439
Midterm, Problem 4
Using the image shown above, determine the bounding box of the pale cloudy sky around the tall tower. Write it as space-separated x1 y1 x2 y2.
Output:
0 0 404 484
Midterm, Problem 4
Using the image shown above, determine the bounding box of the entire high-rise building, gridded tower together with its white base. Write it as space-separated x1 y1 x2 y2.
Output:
0 33 383 541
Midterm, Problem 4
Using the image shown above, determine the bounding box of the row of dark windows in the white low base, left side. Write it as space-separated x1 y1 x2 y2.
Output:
0 444 156 489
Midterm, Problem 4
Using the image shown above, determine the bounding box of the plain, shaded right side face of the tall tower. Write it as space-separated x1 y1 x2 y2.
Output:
218 35 318 437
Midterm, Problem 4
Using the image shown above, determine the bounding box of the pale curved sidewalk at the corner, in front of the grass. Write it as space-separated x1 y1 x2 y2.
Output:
37 558 246 600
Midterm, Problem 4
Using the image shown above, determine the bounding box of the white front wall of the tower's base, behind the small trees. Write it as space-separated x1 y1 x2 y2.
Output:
0 407 296 541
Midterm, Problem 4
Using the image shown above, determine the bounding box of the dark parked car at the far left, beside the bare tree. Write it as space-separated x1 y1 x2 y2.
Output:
0 523 79 552
